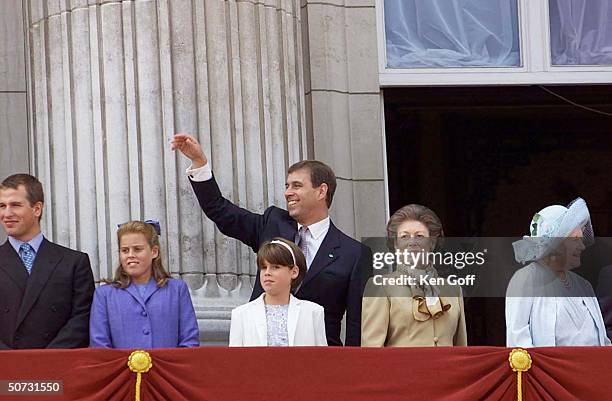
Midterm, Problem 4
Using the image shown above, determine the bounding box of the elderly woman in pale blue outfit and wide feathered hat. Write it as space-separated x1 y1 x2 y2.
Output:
506 198 610 347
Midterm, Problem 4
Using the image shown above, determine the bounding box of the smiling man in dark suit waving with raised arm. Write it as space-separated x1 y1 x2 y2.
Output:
172 134 371 346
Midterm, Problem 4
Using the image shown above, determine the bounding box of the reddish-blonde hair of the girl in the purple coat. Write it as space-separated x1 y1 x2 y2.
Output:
106 221 170 288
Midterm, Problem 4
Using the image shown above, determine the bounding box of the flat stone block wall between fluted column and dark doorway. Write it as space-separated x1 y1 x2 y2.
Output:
302 0 387 239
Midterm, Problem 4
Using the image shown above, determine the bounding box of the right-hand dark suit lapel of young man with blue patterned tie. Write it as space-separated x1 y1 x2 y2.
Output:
15 239 63 327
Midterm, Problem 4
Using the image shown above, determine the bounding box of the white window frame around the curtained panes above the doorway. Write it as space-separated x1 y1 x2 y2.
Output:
376 0 612 87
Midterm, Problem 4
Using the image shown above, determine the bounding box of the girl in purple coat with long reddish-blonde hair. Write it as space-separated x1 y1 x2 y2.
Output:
89 221 199 348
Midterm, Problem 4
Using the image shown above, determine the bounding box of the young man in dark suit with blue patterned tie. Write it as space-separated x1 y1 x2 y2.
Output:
0 174 94 349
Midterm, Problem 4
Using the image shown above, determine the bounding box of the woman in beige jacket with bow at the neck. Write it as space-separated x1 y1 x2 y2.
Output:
361 204 467 347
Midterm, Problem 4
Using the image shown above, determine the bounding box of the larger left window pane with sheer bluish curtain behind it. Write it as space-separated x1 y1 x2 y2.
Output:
384 0 520 68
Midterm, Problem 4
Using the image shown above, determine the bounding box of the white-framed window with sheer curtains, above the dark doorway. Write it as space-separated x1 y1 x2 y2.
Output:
377 0 612 86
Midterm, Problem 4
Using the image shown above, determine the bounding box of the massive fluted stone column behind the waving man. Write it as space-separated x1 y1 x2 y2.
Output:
24 0 312 343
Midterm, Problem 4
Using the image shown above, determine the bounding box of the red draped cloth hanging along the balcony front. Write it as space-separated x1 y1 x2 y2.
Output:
0 347 612 401
